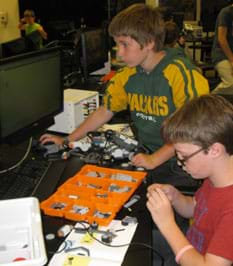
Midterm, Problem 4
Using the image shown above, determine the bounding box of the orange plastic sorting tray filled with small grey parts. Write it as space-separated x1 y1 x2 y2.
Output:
40 164 146 226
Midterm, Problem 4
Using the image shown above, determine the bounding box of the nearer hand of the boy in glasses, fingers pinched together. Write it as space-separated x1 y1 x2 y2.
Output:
146 187 175 233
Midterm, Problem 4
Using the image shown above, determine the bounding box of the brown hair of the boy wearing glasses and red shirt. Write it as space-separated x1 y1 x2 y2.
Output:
162 94 233 155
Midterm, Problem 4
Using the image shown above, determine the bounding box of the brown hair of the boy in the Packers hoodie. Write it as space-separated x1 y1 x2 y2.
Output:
108 4 165 51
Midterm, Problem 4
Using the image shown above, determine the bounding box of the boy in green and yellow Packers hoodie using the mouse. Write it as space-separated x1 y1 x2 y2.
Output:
40 4 209 187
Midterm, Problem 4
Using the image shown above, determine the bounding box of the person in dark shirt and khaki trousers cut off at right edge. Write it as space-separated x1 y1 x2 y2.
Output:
211 0 233 94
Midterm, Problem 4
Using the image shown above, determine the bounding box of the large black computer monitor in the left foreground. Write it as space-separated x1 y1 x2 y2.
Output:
0 48 63 142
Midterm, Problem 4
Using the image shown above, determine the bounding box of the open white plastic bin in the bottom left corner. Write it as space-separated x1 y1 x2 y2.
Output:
0 197 47 266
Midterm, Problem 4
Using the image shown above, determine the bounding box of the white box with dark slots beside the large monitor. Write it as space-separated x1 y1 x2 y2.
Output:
48 89 99 134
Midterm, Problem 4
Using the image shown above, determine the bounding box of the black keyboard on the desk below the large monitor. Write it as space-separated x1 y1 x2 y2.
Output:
0 155 51 199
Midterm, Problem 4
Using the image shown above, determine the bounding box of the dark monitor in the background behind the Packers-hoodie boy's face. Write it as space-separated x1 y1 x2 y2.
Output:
80 28 108 81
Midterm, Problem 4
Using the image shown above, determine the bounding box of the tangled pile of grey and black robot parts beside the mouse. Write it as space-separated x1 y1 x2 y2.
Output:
62 130 149 165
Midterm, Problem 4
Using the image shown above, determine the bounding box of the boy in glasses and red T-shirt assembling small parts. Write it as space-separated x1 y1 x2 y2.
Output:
147 95 233 266
